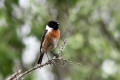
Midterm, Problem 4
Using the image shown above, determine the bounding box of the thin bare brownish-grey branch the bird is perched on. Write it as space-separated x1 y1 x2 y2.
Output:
6 40 68 80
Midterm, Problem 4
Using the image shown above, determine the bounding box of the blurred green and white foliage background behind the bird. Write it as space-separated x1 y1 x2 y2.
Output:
0 0 120 80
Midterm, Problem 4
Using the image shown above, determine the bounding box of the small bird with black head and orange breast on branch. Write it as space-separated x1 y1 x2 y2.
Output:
37 20 60 64
